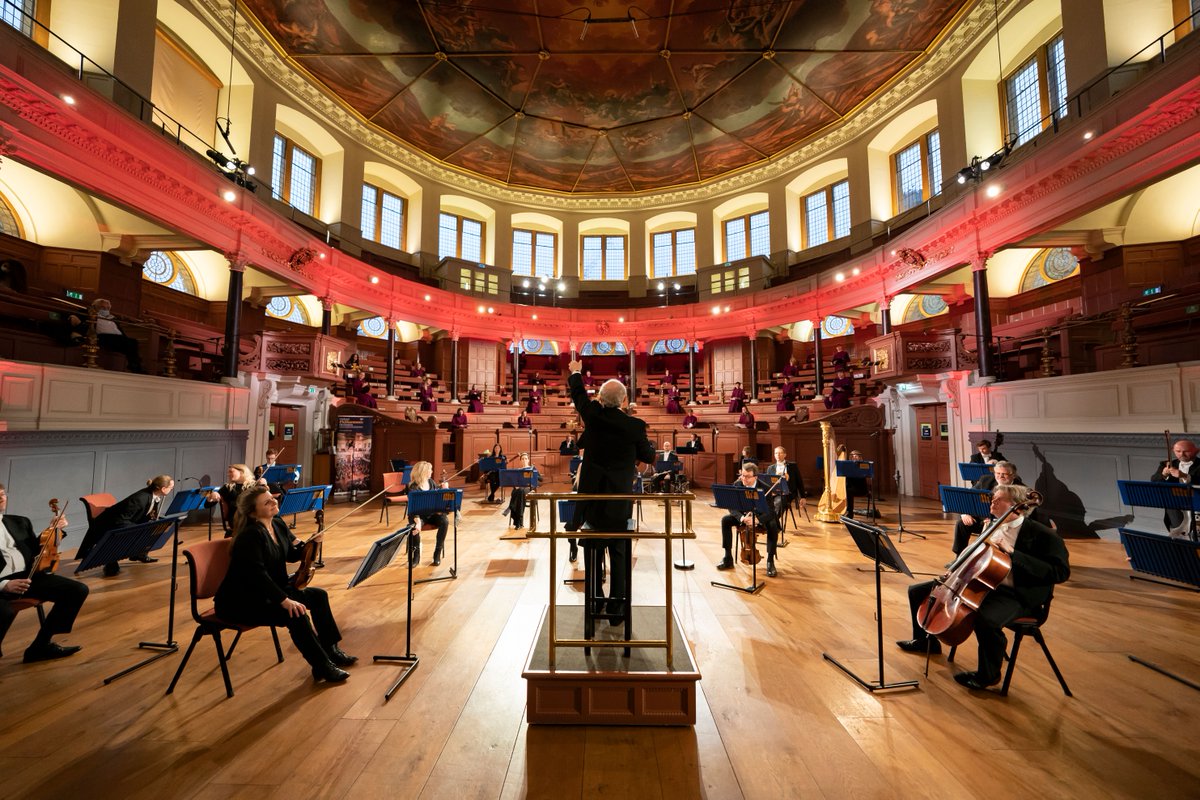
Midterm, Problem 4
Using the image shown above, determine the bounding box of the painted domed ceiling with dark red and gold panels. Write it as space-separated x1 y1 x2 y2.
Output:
244 0 971 194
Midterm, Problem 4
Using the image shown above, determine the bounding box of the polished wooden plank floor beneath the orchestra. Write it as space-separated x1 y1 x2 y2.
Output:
0 482 1200 800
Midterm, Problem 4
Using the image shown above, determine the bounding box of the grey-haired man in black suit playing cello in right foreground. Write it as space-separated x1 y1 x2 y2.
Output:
896 486 1070 690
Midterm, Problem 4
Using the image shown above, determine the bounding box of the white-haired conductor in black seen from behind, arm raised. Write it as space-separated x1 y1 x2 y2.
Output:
566 361 654 620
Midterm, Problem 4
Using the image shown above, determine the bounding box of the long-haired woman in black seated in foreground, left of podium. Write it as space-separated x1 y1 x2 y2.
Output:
214 486 358 682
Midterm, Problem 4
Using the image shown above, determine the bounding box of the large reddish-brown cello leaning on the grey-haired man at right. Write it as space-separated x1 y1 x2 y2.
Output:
917 491 1042 646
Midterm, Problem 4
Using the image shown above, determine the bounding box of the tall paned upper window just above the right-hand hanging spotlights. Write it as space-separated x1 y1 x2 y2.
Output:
1003 34 1067 145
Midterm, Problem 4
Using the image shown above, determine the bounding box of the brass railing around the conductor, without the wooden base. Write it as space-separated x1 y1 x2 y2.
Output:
527 492 696 669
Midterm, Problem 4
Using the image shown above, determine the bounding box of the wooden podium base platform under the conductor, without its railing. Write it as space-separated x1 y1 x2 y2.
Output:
521 606 700 726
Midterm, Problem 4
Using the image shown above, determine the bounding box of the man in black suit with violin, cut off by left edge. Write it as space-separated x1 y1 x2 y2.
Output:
0 483 88 663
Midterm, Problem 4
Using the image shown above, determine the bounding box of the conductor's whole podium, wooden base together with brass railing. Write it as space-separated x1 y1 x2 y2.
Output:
521 492 700 726
